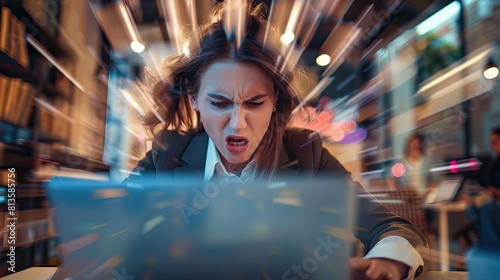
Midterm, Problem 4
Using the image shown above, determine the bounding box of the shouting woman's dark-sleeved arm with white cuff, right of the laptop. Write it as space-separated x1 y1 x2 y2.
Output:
313 140 429 277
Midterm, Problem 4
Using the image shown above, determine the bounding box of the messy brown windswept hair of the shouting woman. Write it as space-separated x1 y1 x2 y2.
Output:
144 1 297 178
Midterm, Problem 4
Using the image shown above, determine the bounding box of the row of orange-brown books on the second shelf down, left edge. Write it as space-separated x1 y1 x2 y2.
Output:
0 74 35 127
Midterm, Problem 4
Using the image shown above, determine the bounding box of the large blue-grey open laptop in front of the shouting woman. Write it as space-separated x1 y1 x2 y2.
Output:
48 177 356 279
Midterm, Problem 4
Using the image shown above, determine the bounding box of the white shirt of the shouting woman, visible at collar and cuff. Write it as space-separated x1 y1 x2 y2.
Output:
203 137 424 280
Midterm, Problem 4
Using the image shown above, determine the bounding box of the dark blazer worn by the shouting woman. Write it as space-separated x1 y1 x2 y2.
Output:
126 130 428 275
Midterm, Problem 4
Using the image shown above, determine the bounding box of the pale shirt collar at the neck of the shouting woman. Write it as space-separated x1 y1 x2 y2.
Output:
203 137 256 182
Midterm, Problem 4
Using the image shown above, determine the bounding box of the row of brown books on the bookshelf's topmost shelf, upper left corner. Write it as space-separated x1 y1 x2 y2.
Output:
0 7 29 68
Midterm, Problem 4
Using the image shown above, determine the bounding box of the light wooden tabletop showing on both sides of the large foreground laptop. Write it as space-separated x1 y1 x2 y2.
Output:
0 267 467 280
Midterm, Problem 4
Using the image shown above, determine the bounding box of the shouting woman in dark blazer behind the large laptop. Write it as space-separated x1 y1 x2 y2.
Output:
128 1 427 279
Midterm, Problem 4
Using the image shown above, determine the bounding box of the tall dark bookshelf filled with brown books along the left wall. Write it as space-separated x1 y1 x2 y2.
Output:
0 0 109 277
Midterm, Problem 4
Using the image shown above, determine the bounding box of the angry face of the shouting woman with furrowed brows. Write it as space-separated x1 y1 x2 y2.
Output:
194 60 276 170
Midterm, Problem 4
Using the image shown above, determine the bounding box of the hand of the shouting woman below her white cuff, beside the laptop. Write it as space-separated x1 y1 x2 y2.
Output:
350 258 410 280
